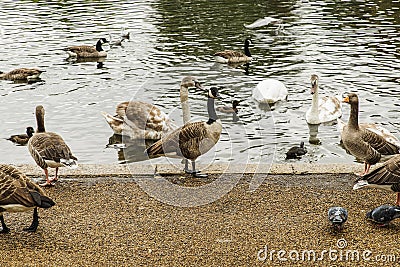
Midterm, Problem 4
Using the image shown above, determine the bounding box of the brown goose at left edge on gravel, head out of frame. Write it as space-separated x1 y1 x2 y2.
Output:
0 164 55 233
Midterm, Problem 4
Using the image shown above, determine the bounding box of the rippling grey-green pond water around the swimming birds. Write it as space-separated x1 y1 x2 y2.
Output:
0 0 400 168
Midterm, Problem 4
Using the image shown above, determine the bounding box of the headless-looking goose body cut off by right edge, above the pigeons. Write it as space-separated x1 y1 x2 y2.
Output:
353 155 400 206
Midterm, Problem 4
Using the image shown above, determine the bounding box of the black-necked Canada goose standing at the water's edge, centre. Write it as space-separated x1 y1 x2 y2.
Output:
145 87 222 178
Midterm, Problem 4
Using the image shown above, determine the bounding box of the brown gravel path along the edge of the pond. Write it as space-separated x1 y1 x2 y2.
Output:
0 174 400 266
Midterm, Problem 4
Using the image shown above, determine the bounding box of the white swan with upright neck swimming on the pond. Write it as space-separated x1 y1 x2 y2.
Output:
306 74 342 124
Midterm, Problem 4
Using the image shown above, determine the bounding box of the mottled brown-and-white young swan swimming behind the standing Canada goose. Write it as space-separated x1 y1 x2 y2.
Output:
102 76 201 140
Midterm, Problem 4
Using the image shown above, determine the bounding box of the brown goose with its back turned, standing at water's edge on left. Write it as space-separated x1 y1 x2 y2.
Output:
28 106 78 186
